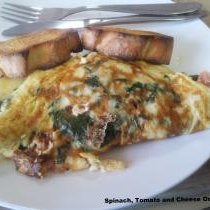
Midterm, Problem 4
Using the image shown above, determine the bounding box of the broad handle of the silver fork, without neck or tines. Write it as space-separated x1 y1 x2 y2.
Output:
93 2 201 15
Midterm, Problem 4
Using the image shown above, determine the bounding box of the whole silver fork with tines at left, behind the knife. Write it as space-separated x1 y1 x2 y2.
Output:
1 2 201 24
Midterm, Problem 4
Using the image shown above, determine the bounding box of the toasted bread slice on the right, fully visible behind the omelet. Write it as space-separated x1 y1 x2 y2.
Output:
81 27 173 64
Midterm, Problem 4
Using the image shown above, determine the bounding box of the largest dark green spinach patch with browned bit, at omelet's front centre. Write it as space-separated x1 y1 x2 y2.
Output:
50 109 122 151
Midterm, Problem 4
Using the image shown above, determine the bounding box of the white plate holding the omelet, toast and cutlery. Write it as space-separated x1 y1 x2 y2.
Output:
0 0 210 210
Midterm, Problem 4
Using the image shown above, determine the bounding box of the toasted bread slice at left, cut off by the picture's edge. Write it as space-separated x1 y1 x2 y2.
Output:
0 29 82 77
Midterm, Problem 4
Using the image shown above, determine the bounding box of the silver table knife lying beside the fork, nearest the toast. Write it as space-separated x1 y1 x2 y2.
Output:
2 12 205 36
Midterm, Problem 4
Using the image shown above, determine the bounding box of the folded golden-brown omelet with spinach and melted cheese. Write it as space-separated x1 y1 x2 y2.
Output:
0 52 210 177
